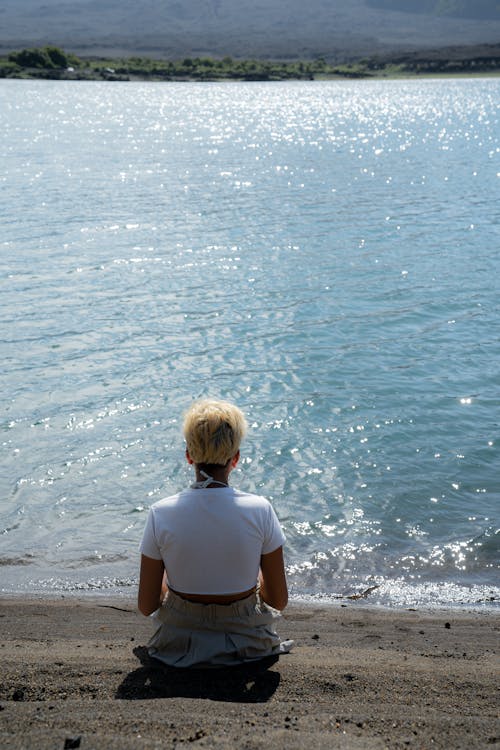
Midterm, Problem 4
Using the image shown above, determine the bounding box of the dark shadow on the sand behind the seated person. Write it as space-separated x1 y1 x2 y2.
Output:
115 646 280 703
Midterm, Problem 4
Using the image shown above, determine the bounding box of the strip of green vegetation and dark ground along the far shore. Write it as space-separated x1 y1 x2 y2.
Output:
0 46 500 81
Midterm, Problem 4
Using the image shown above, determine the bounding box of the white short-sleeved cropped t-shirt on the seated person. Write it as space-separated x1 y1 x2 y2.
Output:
140 487 285 595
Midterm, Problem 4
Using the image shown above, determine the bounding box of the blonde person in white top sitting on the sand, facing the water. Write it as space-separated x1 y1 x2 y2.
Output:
138 399 292 667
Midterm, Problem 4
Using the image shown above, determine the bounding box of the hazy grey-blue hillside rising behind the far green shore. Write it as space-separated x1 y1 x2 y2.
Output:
0 0 500 62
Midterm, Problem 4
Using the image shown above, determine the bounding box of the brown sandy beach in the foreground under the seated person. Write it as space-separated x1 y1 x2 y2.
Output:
0 598 500 750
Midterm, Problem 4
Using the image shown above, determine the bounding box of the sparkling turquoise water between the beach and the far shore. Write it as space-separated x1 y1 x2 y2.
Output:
0 79 500 606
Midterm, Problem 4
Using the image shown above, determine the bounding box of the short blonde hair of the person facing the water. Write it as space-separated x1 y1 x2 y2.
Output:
183 399 247 466
